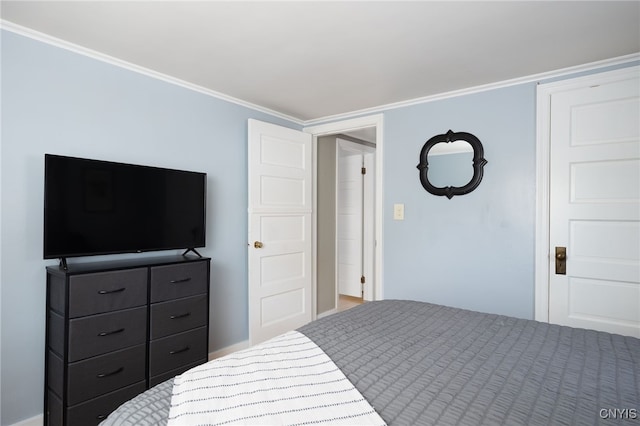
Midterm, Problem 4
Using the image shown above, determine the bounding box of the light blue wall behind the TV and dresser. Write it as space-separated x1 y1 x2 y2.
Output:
0 31 300 425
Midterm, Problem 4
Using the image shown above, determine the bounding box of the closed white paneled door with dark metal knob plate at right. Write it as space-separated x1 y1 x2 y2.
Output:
549 71 640 337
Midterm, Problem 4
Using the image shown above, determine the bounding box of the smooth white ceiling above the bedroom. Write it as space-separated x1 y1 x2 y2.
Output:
0 0 640 122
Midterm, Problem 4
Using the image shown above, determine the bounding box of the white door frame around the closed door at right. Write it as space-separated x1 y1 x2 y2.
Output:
534 66 640 322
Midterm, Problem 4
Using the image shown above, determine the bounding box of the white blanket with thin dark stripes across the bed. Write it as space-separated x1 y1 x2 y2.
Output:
168 331 385 426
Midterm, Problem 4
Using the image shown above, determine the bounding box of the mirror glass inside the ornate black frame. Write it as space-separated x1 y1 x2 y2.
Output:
427 140 473 188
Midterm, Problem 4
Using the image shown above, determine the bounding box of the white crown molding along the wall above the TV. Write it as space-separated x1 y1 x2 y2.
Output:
0 20 304 126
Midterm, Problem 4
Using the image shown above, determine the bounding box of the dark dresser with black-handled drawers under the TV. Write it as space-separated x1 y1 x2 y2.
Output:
44 256 210 426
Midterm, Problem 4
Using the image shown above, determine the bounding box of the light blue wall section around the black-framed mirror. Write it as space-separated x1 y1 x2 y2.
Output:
384 84 536 318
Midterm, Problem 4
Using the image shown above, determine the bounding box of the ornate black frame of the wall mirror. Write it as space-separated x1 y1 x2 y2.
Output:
417 130 487 199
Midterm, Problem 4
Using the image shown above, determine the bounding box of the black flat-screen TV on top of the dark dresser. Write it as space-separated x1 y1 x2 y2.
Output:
44 154 207 259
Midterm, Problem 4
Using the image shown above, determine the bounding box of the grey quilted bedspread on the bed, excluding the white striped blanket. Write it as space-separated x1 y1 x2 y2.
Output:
102 300 640 426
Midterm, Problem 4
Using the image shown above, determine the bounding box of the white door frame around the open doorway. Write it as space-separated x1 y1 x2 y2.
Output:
302 114 384 310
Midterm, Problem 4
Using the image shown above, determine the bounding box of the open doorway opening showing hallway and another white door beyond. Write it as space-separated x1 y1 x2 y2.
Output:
316 127 376 317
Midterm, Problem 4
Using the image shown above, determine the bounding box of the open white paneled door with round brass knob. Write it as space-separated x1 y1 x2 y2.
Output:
248 120 313 344
